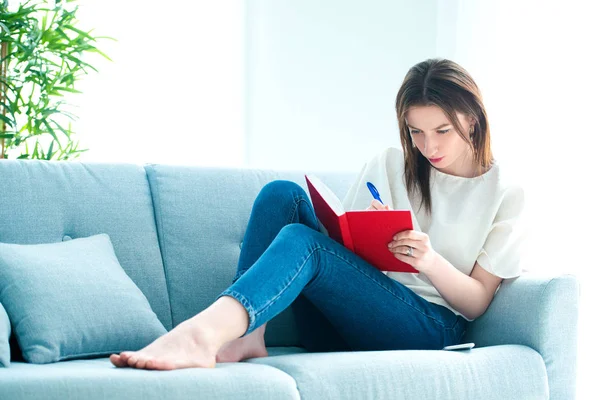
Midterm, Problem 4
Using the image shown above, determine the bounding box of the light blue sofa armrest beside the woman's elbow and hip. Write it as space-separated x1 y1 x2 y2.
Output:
463 272 580 400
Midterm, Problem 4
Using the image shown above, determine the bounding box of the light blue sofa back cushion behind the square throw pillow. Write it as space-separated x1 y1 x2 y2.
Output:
0 160 172 329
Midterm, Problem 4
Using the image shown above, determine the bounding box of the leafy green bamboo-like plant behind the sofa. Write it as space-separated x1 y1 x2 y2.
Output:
0 0 111 160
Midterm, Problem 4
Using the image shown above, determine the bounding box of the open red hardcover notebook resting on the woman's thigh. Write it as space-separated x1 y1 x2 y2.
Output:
304 175 419 273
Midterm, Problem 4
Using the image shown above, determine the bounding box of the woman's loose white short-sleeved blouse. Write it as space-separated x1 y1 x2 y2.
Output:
342 147 525 321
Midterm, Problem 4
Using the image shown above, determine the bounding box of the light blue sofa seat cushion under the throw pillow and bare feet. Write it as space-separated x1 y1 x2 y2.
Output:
0 358 300 400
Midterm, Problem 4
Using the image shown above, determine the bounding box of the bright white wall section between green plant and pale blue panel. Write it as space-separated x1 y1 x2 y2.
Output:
72 0 245 166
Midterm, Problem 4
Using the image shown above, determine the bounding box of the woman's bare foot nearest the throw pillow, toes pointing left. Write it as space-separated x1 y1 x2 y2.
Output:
110 320 220 370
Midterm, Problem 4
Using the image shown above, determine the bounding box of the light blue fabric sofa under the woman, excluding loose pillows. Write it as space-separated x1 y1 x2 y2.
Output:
0 160 579 400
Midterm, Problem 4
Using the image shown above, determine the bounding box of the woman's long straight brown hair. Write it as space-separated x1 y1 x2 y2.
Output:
396 58 493 214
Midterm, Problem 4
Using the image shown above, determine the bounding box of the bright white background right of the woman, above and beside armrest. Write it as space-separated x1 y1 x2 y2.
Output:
438 0 600 399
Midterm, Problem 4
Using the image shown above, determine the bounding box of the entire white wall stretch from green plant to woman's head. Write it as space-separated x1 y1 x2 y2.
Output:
73 0 437 170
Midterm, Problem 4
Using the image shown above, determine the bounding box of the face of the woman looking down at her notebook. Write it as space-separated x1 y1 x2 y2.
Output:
406 105 475 177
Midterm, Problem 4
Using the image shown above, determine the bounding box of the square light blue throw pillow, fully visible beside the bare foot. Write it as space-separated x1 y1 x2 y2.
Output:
0 234 166 364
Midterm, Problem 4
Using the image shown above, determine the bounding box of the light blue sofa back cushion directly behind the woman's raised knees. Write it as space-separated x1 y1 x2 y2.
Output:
146 165 353 346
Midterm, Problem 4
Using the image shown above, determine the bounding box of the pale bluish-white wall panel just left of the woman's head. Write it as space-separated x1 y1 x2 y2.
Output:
246 0 437 171
